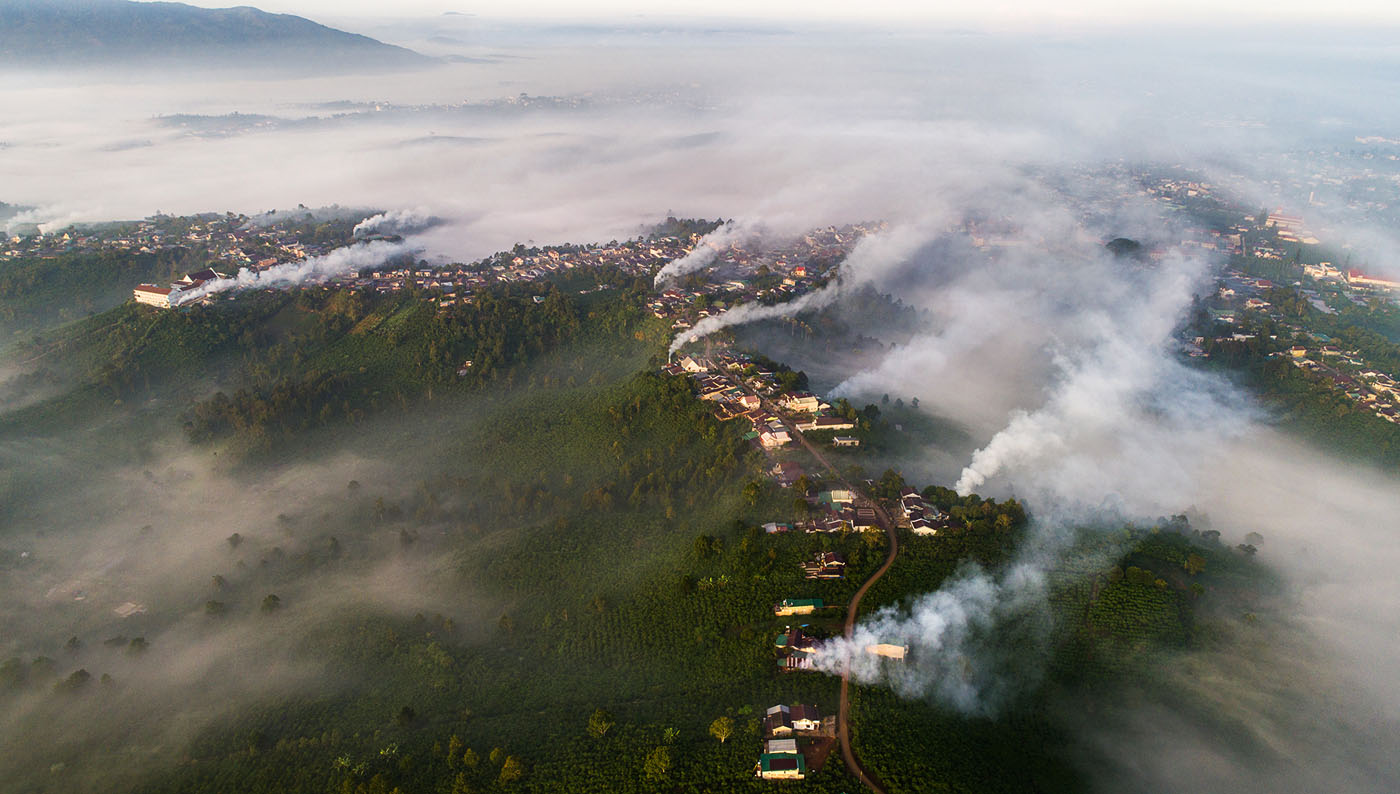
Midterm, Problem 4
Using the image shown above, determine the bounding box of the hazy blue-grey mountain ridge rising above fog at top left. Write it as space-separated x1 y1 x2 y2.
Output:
0 0 433 69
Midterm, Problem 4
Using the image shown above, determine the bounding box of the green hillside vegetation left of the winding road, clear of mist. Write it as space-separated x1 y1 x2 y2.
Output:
6 291 878 791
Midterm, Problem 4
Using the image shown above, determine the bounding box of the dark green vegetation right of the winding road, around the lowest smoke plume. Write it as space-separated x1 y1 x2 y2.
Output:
851 504 1270 793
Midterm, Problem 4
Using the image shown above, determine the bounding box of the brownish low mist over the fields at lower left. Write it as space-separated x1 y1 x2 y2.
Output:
0 397 498 790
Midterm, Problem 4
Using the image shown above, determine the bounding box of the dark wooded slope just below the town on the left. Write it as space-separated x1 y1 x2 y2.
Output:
25 275 645 448
